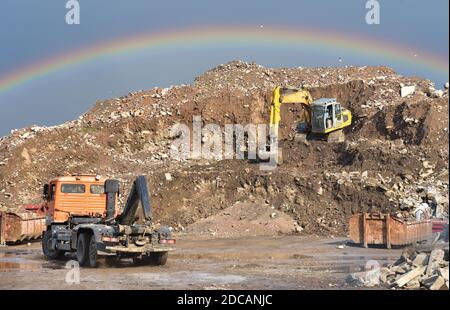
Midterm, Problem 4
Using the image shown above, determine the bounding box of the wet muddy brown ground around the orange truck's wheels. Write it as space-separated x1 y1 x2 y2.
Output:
0 235 402 290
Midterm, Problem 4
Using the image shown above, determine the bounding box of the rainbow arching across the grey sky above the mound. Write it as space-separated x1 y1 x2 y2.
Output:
0 25 448 94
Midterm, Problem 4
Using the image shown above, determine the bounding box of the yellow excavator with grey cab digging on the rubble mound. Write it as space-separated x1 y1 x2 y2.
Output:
270 86 352 162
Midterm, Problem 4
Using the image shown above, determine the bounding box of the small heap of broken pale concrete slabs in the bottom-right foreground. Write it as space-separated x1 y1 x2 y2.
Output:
348 243 449 290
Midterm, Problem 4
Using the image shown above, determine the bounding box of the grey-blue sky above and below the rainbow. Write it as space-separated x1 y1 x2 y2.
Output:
0 0 449 136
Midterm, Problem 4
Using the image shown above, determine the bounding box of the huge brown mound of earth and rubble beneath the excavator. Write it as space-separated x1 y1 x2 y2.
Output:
0 61 448 235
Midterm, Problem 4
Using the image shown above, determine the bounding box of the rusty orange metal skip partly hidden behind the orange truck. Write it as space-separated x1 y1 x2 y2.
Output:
0 212 46 245
